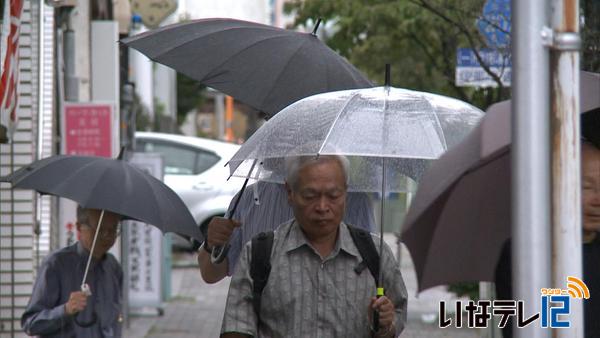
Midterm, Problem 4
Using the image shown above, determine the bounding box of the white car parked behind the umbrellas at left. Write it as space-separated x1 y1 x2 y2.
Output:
135 132 243 249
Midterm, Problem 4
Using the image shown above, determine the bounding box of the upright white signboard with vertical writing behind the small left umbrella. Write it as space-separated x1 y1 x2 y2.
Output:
123 153 163 308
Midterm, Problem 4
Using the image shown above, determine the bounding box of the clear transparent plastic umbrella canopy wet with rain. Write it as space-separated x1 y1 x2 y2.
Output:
229 86 483 192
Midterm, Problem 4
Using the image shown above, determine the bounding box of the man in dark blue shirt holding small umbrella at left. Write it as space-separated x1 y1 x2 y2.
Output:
21 207 123 338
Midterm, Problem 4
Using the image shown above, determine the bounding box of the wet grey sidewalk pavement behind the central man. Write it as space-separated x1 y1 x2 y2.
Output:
124 236 480 338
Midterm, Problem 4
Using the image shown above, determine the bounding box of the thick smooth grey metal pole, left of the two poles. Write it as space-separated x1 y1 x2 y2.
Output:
511 0 551 338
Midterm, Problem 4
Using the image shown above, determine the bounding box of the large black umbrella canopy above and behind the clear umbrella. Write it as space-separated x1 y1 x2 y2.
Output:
122 19 372 116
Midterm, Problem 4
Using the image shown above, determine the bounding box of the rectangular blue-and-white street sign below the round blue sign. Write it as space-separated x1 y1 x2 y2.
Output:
455 48 511 87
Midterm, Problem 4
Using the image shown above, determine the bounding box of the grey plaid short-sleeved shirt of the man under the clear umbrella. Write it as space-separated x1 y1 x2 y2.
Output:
221 220 407 337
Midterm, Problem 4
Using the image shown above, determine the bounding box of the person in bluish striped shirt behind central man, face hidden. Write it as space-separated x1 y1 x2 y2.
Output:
198 181 375 283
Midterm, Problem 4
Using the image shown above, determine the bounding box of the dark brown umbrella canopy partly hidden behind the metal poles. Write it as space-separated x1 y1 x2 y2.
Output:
402 72 600 291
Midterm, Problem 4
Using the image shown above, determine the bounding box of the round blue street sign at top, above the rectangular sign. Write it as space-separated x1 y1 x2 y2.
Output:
477 0 511 48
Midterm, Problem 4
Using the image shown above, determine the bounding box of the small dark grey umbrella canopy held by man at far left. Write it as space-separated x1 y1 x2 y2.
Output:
0 155 202 241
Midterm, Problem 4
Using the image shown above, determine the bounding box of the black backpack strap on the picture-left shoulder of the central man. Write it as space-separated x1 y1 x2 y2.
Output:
250 231 273 318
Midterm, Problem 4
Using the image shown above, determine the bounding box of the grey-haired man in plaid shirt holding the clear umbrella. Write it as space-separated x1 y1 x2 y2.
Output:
221 156 406 337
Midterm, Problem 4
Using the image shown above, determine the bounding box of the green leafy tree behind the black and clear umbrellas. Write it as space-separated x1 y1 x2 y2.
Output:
286 0 509 108
